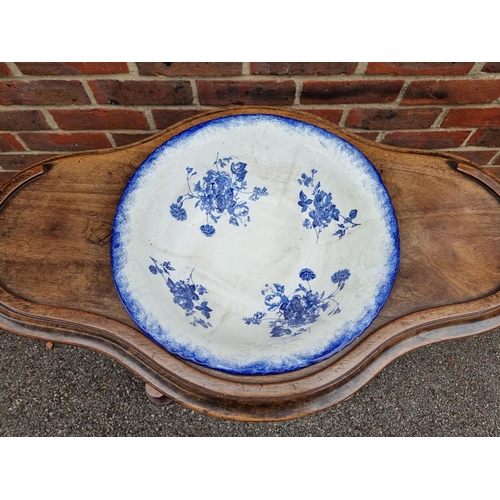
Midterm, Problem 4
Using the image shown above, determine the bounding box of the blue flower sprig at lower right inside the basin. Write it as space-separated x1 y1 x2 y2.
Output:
243 268 351 337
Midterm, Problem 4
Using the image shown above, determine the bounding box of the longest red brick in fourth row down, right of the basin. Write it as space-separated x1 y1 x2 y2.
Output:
382 130 470 149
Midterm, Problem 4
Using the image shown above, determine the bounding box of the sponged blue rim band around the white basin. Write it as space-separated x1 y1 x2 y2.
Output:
110 113 400 375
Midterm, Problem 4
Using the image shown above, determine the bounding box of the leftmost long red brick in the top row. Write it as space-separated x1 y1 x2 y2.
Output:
16 62 129 75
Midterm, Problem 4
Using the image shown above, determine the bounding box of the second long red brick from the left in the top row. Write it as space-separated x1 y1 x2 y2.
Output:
136 62 242 76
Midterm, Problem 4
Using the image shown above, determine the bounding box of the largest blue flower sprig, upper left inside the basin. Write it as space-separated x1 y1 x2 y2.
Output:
170 154 268 237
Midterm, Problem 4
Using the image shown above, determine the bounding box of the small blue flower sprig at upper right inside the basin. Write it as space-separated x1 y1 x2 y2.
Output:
297 168 360 243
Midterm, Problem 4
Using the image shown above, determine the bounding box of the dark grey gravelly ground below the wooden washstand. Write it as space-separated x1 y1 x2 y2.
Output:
0 329 500 436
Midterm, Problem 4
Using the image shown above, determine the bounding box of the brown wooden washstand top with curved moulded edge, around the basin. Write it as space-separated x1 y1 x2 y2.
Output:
0 107 500 420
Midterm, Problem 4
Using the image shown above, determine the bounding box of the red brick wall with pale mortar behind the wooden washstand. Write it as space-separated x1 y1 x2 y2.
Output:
0 62 500 177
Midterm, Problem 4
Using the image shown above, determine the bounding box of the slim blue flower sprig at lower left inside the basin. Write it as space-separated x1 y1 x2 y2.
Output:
149 257 212 328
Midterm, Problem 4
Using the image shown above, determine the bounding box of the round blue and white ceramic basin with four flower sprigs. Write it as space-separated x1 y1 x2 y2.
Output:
111 114 399 375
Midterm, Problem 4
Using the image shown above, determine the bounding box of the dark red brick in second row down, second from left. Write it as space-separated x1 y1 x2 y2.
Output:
89 80 193 106
